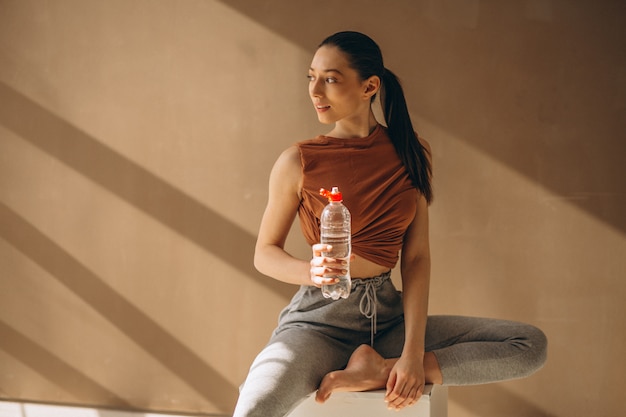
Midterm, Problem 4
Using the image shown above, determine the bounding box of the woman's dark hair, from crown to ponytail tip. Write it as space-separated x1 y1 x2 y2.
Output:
319 31 433 203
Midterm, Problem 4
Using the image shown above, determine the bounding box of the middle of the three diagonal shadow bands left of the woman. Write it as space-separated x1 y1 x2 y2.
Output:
0 202 237 412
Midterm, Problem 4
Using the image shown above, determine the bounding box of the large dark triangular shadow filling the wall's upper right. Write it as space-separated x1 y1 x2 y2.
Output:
220 0 626 233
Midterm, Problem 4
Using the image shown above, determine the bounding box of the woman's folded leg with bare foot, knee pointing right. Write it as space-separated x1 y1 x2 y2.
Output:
318 316 547 399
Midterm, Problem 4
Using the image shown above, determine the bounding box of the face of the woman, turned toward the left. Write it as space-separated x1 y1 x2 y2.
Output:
309 45 376 124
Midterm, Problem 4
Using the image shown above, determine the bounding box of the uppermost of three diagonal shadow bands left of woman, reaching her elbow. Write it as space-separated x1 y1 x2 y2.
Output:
0 81 294 300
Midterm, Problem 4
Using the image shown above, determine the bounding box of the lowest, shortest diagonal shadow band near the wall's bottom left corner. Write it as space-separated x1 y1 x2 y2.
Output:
0 318 130 407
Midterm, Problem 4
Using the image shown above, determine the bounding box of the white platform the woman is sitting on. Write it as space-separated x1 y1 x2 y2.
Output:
286 385 448 417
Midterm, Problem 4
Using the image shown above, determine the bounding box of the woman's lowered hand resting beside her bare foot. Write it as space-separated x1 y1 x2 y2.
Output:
385 355 425 410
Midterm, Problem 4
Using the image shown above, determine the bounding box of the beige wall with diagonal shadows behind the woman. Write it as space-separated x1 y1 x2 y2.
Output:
0 0 626 417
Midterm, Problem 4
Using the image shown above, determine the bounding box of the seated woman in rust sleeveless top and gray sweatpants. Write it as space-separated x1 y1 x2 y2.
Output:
230 32 546 417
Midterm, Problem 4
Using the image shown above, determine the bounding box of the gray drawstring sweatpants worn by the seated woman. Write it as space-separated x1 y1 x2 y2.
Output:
234 274 547 417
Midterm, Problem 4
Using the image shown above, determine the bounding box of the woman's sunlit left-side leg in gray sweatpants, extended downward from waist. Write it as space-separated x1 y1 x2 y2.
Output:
235 276 394 417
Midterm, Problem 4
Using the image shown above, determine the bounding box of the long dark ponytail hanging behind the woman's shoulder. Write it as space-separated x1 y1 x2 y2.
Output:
381 68 433 203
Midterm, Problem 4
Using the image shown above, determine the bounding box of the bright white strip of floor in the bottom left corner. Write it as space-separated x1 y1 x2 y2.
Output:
0 401 201 417
